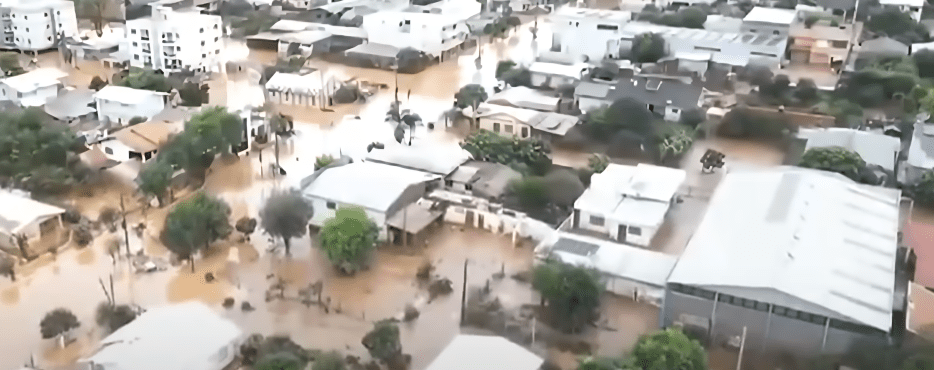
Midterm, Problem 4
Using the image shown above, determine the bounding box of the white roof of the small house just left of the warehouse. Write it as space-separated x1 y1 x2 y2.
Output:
574 163 687 226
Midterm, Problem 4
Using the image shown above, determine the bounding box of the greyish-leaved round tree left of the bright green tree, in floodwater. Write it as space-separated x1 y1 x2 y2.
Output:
259 189 314 254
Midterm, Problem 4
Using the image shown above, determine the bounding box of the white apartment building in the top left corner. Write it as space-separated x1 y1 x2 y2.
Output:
0 0 78 51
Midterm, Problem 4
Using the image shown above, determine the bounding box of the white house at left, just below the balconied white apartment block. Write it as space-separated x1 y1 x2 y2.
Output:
94 85 168 126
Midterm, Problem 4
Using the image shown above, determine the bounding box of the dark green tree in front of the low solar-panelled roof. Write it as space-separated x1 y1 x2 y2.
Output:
532 261 604 331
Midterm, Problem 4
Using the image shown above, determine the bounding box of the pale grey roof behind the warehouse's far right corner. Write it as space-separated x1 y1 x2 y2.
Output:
798 127 902 171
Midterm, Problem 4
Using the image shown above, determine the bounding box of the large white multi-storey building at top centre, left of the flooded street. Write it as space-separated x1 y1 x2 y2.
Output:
362 11 479 61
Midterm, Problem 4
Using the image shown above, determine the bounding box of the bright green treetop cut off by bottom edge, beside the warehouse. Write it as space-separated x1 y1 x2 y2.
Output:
628 328 707 370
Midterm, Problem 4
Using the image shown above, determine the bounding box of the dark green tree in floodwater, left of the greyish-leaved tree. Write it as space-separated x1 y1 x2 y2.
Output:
165 192 233 272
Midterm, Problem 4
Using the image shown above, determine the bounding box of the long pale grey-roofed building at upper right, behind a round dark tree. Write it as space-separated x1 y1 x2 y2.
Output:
620 22 788 68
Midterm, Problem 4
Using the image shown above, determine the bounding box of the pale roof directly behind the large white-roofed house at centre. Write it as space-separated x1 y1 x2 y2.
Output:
366 142 470 177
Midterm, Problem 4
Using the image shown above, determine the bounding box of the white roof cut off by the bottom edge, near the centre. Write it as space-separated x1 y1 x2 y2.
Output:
426 334 545 370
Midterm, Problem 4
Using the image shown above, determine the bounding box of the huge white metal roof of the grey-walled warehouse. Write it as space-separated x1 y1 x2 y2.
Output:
668 167 901 332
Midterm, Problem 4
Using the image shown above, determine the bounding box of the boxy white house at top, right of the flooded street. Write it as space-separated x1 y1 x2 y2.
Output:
549 7 632 63
